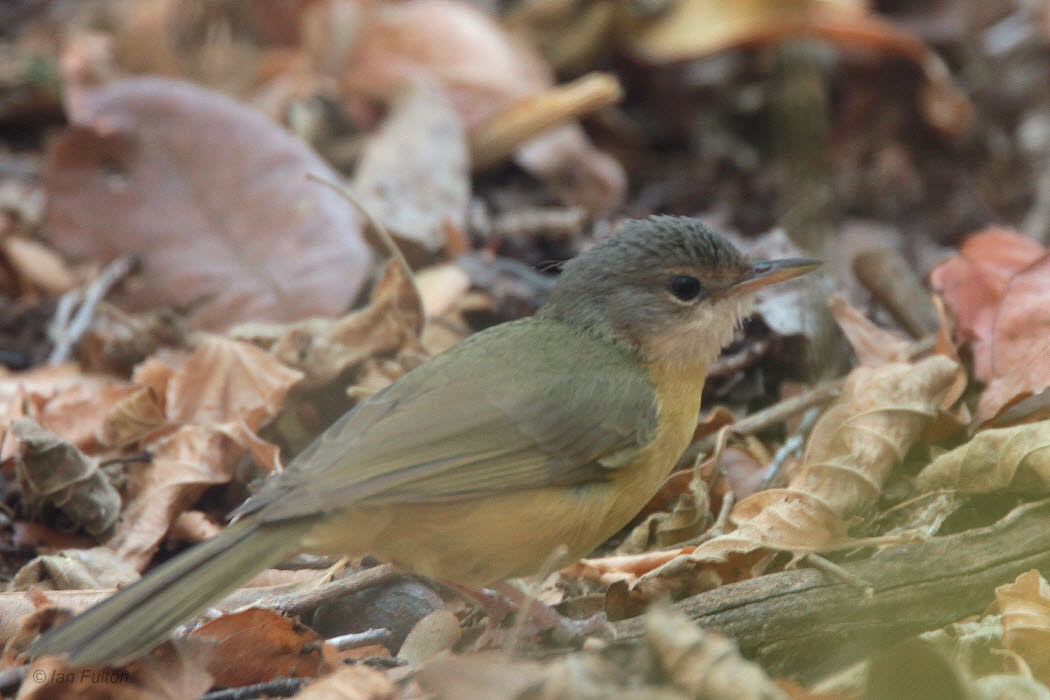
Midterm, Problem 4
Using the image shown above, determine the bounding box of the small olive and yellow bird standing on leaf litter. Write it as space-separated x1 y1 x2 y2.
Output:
27 216 820 665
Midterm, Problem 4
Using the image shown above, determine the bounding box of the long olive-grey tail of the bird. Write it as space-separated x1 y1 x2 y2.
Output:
26 517 312 665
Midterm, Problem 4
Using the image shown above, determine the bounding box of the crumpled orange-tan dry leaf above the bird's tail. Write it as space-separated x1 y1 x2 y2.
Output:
102 334 302 569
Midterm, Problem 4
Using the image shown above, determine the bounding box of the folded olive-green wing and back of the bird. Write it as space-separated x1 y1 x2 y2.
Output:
242 325 657 519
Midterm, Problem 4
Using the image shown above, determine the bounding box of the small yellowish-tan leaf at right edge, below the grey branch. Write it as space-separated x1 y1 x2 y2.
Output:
995 569 1050 683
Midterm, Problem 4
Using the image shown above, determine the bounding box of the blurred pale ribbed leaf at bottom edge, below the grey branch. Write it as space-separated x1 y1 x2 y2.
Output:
644 606 788 700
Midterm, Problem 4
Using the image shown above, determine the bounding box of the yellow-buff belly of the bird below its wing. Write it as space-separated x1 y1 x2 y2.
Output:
303 391 698 585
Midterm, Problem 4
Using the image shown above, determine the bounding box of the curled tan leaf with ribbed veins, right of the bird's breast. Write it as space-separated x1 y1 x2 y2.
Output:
634 356 957 594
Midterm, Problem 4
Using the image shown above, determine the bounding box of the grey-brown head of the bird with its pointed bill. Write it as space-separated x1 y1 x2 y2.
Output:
541 216 820 370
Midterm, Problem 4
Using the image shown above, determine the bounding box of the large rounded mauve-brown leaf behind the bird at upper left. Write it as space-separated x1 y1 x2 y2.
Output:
46 78 371 328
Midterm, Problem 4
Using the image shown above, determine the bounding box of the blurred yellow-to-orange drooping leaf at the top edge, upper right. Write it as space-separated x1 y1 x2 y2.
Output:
631 0 974 139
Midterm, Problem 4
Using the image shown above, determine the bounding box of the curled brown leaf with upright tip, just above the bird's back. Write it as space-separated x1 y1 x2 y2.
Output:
232 260 423 386
